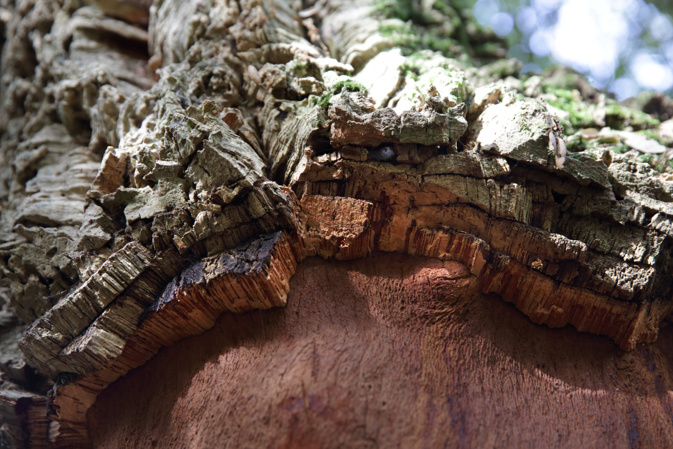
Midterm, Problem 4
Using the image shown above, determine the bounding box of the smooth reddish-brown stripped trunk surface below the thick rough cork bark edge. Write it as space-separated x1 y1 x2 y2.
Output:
88 254 673 449
